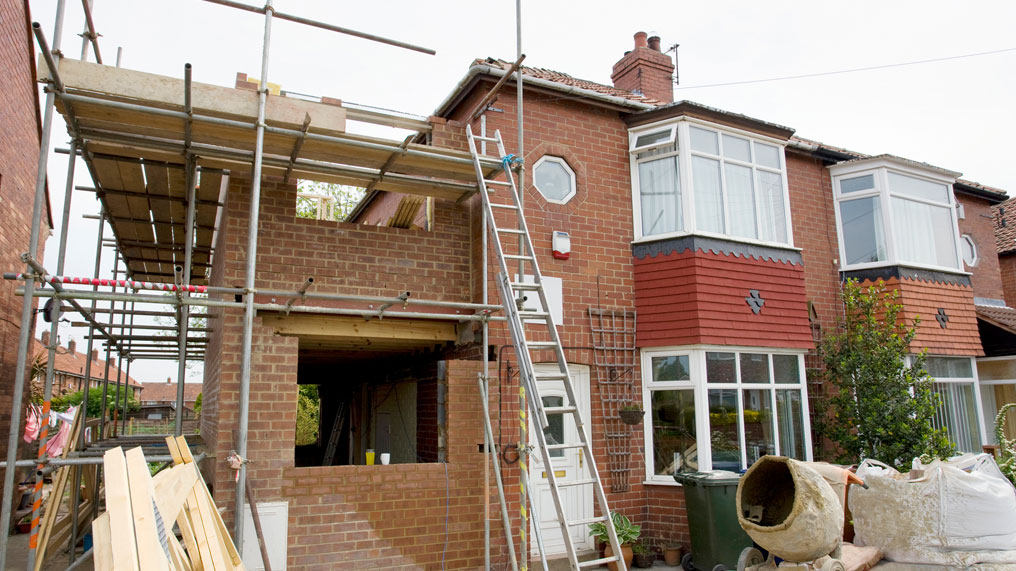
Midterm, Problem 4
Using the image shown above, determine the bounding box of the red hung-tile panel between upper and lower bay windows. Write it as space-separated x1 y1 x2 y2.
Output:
635 250 812 348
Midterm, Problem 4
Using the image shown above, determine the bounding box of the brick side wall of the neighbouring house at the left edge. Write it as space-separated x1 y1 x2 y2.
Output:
0 0 53 457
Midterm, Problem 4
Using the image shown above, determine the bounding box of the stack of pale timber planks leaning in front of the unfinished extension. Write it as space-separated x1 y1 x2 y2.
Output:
91 436 244 571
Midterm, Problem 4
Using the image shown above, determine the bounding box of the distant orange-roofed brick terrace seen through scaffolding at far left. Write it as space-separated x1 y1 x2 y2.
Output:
30 331 143 400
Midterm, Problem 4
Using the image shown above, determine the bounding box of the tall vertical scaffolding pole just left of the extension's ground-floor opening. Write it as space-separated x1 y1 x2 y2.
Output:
234 0 274 553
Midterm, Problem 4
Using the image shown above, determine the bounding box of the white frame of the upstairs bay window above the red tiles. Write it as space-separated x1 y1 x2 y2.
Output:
628 117 793 249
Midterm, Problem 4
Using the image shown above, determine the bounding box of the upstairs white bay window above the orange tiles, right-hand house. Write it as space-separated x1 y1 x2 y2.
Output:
831 160 961 270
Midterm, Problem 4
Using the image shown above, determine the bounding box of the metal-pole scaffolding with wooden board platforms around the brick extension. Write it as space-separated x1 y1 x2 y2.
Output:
0 0 516 569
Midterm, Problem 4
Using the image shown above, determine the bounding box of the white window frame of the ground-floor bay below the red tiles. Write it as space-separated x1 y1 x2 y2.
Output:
640 345 812 486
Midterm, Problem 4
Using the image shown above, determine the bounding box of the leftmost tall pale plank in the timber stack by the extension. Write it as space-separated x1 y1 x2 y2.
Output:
103 446 140 571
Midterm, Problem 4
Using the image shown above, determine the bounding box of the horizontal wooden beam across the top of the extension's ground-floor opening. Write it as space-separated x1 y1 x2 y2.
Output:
260 313 458 341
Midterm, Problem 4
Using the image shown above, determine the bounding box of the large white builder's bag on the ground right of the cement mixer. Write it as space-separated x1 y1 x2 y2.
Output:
849 454 1016 567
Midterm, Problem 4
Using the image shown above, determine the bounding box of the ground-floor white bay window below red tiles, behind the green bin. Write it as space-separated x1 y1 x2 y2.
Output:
642 348 811 484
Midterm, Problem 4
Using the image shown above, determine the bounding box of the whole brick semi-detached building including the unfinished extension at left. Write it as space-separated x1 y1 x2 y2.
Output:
33 25 1011 569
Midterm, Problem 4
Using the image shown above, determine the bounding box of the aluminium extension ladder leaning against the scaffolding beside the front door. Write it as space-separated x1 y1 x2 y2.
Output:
466 125 627 571
